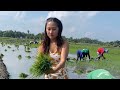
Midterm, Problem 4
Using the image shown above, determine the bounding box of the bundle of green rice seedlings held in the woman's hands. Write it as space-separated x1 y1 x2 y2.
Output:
30 54 52 77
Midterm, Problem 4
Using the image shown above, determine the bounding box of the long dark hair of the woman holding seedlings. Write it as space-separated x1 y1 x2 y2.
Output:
43 17 64 54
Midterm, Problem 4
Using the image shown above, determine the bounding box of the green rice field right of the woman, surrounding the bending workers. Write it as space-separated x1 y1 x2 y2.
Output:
67 43 120 76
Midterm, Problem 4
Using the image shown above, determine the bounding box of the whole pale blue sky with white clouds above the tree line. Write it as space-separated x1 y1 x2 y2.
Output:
0 11 120 41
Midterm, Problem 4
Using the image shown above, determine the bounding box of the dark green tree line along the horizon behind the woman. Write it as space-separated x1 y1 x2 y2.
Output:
0 30 120 47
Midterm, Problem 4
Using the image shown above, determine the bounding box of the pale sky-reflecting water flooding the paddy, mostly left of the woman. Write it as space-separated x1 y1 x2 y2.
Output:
0 44 86 79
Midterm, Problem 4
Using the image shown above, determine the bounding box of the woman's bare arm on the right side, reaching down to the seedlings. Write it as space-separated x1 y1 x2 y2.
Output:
53 41 69 72
